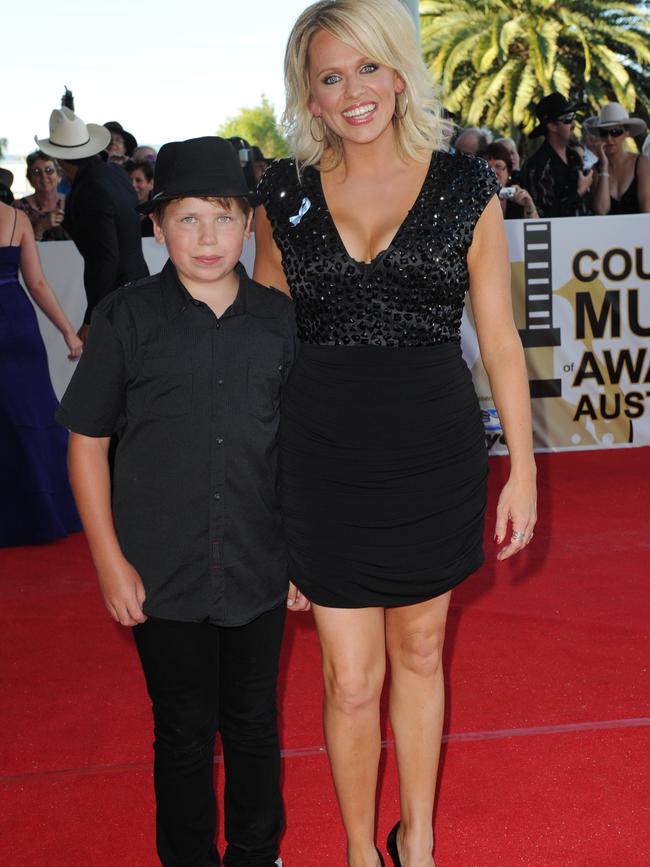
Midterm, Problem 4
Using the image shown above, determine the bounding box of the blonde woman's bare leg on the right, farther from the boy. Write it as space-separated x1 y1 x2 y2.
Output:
386 593 451 867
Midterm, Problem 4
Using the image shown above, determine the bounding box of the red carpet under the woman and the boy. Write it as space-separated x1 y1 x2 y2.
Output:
0 448 650 867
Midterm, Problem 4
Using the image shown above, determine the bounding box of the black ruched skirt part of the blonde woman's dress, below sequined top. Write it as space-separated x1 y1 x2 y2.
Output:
280 343 487 608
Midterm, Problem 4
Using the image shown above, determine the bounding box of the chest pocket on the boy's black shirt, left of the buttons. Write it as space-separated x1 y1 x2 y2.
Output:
130 356 193 418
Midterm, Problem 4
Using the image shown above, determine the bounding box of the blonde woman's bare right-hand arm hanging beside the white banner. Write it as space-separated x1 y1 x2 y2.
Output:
467 196 537 560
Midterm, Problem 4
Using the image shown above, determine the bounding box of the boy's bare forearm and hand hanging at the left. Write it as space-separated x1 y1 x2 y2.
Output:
68 433 147 626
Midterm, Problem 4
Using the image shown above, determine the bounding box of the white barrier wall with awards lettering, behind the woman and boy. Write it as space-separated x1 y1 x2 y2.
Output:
29 214 650 454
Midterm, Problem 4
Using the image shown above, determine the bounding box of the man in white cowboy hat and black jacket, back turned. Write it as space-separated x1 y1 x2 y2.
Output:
36 108 149 339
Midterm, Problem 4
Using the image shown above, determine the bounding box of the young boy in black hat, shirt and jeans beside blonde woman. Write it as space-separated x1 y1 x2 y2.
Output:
57 137 295 867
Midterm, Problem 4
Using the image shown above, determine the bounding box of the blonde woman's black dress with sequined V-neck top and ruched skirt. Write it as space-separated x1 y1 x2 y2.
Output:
260 152 498 608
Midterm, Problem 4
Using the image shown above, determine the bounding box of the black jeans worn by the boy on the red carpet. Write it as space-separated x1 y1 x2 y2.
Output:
133 605 286 867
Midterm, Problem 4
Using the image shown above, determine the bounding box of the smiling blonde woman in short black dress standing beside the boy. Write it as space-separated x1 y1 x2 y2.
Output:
255 0 536 867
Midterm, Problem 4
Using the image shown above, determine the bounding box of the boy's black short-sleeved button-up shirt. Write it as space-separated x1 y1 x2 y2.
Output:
57 262 295 626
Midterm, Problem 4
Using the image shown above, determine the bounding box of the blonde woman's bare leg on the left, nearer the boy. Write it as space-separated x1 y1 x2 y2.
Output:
313 605 386 867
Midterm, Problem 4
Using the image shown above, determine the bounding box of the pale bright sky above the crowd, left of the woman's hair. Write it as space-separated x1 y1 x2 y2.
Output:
0 0 309 156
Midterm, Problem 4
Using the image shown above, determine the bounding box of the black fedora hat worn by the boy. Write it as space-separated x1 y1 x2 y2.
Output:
136 135 256 214
